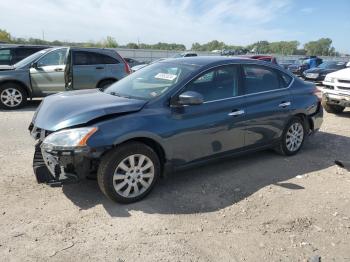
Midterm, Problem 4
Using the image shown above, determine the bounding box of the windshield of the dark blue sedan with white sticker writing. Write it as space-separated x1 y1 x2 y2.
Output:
104 62 197 100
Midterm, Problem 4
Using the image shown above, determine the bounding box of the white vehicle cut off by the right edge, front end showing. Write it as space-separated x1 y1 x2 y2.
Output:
322 62 350 114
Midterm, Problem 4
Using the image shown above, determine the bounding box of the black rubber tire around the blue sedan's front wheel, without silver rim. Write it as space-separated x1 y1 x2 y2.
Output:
97 142 161 204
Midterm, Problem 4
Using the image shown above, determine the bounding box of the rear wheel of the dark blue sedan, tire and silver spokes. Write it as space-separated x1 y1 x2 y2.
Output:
276 117 306 156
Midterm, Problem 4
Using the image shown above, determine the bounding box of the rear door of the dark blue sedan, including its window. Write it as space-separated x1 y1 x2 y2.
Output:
242 64 292 147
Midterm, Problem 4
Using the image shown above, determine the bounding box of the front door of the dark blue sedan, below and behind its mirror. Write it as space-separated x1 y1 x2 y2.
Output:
170 65 245 164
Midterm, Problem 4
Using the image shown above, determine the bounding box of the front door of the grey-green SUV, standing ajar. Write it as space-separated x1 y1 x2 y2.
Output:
30 48 68 95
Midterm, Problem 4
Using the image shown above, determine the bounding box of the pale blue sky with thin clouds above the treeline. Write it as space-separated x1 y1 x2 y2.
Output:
0 0 350 51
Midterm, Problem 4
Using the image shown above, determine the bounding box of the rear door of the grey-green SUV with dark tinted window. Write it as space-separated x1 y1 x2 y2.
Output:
72 50 106 89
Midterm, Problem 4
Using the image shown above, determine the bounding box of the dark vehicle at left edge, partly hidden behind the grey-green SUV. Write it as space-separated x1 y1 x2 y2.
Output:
0 45 49 65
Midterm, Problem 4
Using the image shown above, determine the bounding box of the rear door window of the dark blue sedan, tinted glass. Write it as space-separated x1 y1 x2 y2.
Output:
243 65 281 94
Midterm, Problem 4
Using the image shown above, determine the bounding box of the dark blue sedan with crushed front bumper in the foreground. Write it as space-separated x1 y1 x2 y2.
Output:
29 57 323 203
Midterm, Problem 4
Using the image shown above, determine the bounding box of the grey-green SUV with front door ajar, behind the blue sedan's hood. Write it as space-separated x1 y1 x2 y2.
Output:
0 47 130 109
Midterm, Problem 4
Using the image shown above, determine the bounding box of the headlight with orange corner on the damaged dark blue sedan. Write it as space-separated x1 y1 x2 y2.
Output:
42 127 97 151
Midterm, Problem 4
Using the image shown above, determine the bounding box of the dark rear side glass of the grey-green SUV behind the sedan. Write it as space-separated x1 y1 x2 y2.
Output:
73 51 119 65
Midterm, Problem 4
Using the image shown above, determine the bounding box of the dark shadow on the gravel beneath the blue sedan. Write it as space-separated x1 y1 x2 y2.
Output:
63 132 350 217
